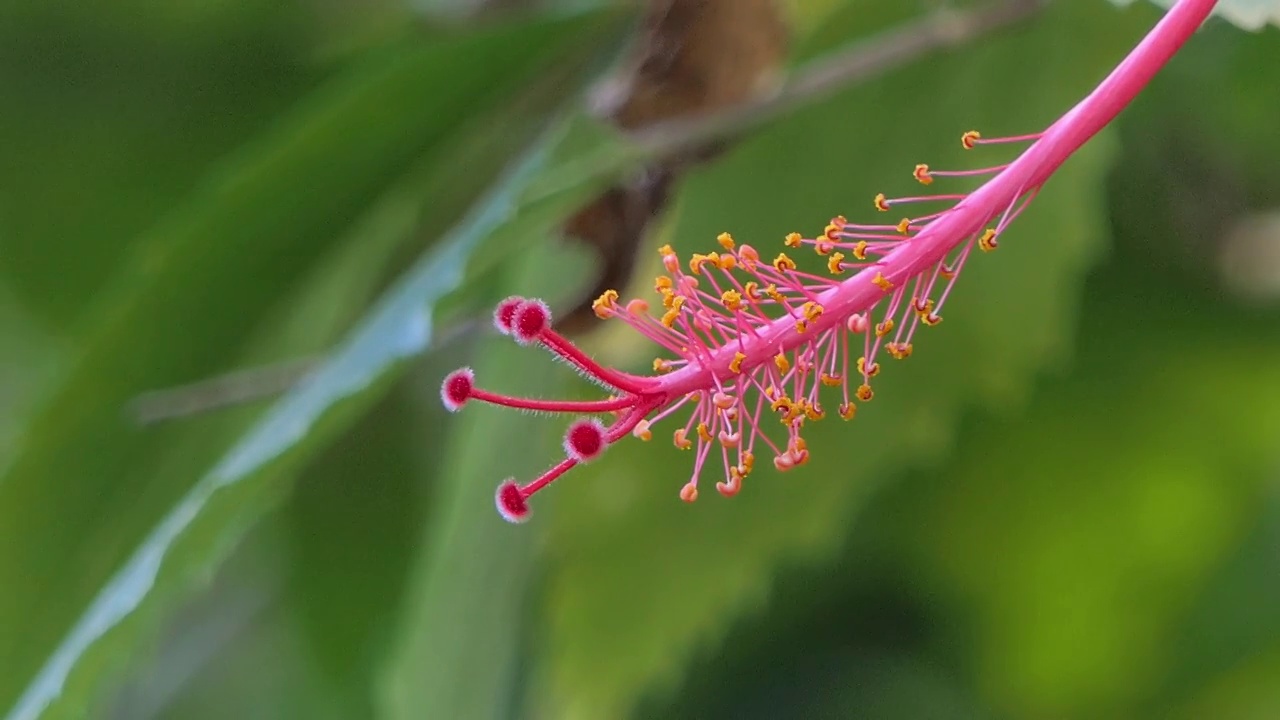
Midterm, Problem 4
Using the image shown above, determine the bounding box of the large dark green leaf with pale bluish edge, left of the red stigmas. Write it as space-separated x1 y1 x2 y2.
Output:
0 13 617 717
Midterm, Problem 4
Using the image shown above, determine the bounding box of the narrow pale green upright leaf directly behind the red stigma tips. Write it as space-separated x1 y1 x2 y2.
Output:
380 237 596 720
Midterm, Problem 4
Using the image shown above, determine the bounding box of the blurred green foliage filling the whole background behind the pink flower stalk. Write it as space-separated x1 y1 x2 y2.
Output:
0 0 1280 719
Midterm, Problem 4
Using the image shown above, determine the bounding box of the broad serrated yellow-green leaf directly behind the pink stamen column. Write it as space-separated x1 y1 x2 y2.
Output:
534 4 1162 719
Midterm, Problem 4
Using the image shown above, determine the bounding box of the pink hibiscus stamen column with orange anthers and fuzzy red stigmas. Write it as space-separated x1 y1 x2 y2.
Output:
440 0 1217 521
